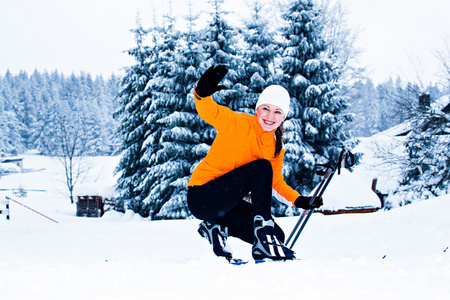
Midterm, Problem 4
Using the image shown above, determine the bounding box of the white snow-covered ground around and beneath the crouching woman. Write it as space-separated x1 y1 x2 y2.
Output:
0 138 450 300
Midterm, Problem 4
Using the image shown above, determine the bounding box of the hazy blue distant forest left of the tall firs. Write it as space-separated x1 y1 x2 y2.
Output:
1 70 118 155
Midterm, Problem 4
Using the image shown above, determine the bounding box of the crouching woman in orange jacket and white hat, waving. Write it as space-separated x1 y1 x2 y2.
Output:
187 65 322 260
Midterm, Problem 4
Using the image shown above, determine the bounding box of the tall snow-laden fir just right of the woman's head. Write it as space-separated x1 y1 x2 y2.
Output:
281 0 351 193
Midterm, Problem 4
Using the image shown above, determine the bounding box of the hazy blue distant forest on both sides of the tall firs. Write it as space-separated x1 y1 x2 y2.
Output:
0 71 445 159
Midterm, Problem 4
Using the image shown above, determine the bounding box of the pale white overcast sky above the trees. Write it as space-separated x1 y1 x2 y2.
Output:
0 0 450 83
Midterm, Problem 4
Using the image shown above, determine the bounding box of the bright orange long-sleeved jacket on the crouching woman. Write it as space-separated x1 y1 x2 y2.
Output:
188 93 300 204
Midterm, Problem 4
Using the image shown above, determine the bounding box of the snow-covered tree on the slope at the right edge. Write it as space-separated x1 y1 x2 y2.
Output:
388 93 450 208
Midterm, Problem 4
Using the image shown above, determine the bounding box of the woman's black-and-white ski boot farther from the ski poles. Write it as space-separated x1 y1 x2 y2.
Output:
198 221 233 260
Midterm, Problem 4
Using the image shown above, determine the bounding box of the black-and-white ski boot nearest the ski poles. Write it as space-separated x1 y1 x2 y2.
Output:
252 215 295 261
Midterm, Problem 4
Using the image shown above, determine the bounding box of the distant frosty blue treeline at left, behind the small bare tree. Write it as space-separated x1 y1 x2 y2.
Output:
0 71 120 155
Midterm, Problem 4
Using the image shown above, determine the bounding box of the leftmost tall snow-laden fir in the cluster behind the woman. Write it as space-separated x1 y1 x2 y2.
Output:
116 19 156 216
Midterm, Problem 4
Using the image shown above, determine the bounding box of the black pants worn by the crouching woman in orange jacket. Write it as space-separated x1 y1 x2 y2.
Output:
187 159 284 244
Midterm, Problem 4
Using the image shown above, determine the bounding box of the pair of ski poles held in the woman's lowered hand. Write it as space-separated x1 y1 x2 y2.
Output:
286 149 354 249
